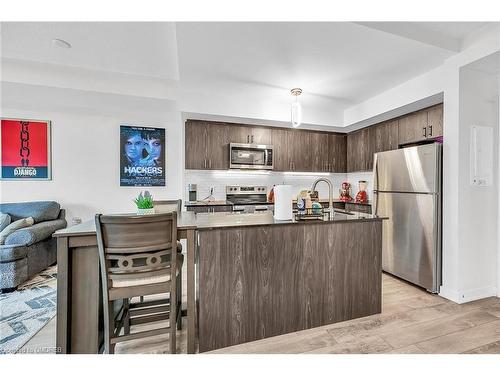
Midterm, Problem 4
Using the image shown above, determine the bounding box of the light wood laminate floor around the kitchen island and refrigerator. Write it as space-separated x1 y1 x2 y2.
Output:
20 274 500 354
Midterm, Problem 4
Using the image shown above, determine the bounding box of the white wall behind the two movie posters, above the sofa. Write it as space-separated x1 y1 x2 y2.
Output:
0 82 183 224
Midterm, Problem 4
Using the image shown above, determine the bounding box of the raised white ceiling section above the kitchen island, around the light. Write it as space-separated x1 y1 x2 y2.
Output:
177 22 468 103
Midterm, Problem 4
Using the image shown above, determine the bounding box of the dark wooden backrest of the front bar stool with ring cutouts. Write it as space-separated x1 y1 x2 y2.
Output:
95 211 177 292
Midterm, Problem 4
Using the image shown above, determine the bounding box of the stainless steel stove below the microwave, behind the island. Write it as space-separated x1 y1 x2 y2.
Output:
226 185 272 212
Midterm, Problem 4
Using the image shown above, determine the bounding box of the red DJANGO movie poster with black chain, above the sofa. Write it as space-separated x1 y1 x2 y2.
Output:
0 118 52 180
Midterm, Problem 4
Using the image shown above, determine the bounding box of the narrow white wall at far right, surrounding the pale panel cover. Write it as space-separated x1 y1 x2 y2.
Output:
457 67 498 301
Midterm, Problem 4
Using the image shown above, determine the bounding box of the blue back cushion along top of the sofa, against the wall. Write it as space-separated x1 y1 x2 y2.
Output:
0 201 61 223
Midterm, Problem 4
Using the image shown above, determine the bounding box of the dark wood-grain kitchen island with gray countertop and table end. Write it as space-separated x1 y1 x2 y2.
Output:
55 212 382 353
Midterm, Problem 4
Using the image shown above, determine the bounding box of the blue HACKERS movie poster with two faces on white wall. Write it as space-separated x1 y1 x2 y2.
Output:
120 126 165 186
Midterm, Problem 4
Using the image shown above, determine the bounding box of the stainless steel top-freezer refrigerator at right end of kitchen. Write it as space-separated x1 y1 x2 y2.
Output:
373 143 442 293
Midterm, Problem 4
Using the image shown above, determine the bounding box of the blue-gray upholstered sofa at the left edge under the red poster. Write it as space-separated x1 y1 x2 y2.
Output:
0 201 66 292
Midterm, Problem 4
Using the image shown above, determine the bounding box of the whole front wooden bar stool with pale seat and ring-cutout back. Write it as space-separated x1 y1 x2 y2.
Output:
95 212 183 353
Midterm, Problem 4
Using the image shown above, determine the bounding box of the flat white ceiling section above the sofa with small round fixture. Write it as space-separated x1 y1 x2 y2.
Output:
1 22 179 79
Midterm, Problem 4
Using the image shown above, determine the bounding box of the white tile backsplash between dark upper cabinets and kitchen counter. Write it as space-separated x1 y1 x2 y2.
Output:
184 170 373 201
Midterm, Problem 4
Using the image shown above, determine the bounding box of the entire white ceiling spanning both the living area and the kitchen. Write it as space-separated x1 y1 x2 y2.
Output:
0 22 492 125
